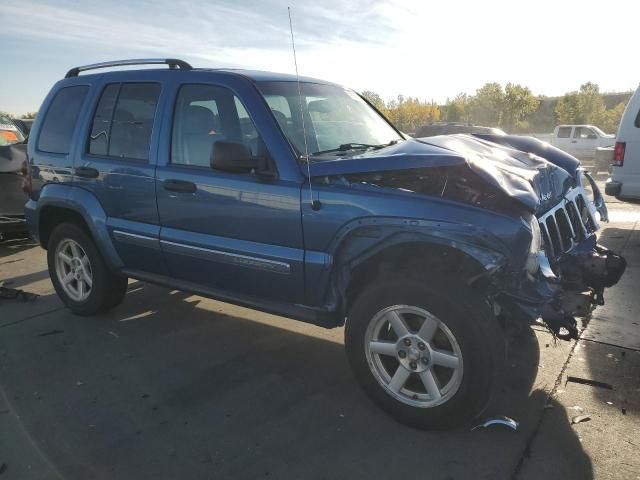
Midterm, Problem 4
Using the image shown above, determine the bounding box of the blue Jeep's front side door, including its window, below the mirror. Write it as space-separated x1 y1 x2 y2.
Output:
156 79 304 303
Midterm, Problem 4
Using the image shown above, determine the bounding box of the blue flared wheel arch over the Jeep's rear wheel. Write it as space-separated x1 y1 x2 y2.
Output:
25 183 123 271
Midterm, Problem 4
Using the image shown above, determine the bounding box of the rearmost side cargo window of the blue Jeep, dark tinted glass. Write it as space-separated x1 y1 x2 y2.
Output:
38 85 89 153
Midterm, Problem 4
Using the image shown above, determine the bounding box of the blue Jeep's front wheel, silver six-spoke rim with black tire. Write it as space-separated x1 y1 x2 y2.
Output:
345 278 504 430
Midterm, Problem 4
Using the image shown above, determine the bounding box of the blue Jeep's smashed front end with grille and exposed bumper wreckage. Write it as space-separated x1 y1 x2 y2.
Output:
496 170 626 340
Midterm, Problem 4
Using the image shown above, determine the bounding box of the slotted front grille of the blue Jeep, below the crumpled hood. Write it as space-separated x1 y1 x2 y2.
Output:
538 187 599 258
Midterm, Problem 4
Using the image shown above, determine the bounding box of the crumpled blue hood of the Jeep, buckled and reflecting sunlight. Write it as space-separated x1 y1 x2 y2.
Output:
304 135 573 212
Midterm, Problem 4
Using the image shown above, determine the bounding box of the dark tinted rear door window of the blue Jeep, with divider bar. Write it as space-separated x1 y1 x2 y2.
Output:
89 83 160 160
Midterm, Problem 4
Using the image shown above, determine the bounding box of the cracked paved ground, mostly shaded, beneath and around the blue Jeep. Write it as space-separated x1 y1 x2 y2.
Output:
0 174 640 480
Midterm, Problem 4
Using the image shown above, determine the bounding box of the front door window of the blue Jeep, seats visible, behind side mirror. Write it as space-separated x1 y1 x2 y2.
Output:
171 85 260 167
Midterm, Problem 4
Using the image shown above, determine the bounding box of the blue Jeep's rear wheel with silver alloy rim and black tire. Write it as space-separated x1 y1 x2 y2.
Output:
47 223 127 315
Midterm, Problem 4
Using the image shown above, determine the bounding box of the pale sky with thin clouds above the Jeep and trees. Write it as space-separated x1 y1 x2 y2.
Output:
0 0 640 114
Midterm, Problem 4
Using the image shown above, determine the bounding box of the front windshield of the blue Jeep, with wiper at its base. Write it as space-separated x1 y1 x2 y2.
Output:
258 82 402 160
